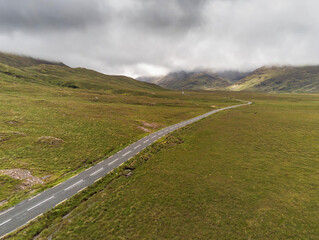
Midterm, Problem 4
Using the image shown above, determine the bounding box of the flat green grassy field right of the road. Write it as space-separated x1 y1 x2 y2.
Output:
7 92 319 239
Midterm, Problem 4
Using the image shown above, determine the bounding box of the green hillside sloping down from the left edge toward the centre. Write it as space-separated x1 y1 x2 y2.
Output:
0 53 164 94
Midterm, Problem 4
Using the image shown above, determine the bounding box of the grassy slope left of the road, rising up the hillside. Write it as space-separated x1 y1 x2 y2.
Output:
0 54 238 209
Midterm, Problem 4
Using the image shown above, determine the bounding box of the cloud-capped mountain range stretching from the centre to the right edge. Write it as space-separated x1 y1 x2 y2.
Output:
137 65 319 93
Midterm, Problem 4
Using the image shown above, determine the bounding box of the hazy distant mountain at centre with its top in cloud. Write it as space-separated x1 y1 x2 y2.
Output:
139 71 231 90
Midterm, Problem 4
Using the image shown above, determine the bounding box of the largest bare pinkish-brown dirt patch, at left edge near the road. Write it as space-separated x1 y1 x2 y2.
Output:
0 168 43 189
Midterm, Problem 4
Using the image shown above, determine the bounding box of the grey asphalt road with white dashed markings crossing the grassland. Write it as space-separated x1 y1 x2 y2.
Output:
0 102 251 237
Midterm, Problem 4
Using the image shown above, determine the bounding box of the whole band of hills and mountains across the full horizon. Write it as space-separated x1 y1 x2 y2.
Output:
4 52 319 94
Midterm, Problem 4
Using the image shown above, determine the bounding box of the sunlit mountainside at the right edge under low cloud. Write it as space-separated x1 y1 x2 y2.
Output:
228 66 319 93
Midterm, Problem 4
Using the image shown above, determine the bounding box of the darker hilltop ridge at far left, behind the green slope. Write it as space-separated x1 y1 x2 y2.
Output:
0 52 66 67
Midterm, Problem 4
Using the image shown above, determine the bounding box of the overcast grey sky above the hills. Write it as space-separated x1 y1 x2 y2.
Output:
0 0 319 77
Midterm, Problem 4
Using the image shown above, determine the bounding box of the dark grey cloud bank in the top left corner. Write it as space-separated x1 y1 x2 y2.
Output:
0 0 107 32
